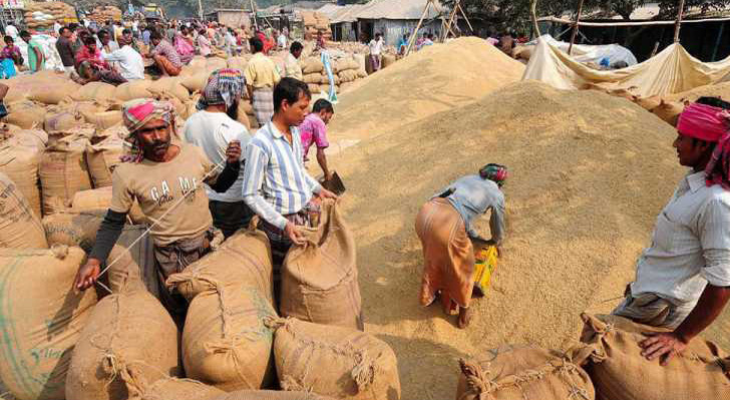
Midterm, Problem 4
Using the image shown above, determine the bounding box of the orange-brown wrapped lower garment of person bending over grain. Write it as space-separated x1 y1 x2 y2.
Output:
416 198 474 310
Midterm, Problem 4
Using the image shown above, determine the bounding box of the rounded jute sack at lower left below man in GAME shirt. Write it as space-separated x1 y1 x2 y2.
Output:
66 272 181 400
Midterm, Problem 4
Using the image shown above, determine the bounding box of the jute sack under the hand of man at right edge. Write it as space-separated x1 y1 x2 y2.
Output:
574 314 730 400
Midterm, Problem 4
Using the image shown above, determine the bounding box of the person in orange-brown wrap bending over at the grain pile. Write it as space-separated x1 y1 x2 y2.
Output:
416 164 507 329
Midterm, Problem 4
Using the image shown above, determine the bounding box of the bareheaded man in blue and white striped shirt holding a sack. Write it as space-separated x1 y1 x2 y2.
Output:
243 78 337 298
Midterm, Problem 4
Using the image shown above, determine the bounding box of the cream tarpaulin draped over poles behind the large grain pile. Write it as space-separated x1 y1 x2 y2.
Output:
523 40 730 97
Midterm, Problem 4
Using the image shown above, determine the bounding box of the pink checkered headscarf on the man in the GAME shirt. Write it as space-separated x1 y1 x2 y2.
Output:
122 99 175 162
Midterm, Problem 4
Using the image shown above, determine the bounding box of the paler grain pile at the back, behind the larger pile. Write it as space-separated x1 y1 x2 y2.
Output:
330 38 525 140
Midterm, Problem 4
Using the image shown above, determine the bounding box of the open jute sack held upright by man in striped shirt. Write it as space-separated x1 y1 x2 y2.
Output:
279 201 363 330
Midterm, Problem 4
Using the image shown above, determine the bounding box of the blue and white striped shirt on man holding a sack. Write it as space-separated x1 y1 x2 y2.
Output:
243 122 321 230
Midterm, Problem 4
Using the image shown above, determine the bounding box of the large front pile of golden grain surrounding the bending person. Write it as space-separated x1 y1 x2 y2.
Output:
331 81 704 400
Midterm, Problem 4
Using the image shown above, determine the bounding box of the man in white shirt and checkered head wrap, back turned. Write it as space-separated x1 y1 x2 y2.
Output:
183 68 253 237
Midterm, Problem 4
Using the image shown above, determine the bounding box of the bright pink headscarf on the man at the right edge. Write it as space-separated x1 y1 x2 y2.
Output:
677 103 730 190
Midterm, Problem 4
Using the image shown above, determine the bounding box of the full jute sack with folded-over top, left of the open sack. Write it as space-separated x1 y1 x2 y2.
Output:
167 231 276 391
